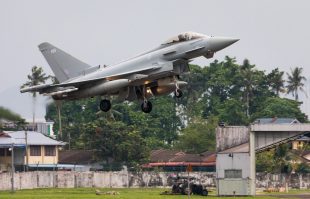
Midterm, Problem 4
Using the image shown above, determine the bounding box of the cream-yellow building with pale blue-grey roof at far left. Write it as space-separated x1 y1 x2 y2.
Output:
0 131 65 171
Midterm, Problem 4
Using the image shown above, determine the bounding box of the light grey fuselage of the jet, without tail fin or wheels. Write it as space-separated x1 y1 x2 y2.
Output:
53 33 237 99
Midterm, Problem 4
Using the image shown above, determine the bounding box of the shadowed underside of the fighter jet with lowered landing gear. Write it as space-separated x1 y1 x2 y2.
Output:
53 76 187 113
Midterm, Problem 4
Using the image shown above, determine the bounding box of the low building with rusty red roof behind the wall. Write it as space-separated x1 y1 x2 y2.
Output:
143 149 216 172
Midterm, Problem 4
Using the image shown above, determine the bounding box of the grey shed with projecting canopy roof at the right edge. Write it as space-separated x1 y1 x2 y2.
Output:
216 118 310 196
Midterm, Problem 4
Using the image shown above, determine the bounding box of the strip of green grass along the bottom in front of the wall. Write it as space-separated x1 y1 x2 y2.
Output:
0 188 310 199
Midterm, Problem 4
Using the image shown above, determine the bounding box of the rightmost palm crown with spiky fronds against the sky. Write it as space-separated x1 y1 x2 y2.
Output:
286 67 307 101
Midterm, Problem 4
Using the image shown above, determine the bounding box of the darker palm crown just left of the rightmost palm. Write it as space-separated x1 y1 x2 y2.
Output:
267 68 285 96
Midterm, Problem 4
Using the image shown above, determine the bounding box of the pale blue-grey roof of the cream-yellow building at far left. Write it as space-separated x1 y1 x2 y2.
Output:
0 131 65 145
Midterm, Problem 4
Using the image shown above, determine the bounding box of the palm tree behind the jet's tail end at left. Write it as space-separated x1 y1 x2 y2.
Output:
21 66 50 126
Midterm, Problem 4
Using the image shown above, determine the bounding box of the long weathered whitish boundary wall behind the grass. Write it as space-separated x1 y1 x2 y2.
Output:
0 171 310 190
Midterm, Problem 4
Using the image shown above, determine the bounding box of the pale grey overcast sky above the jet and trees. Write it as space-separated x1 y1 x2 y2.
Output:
0 0 310 118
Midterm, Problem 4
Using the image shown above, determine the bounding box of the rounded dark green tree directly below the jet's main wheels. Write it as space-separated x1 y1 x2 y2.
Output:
93 120 149 167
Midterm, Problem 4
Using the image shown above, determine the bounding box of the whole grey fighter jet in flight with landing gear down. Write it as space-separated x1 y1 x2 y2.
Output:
20 32 239 113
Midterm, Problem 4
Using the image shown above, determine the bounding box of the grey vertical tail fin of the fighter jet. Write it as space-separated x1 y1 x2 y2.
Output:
39 42 91 82
